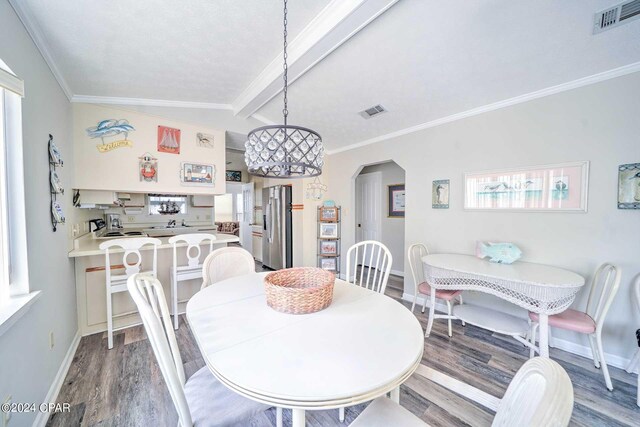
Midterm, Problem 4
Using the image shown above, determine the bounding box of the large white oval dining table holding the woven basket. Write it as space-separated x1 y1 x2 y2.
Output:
186 273 424 427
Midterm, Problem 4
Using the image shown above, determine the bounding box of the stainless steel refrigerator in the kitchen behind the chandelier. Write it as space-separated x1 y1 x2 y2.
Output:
262 185 293 270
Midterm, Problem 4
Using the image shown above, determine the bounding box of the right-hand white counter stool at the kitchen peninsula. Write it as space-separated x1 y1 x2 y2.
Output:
169 233 216 329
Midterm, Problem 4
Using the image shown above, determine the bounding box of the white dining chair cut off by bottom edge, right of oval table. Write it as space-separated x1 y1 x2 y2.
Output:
351 357 573 427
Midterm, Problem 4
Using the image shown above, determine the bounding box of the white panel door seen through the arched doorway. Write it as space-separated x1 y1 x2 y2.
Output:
356 172 382 243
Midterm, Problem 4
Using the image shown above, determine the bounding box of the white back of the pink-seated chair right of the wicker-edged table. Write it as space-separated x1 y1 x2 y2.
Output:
587 263 621 328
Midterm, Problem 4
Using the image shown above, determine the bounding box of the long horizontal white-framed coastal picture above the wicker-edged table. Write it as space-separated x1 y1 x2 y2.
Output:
464 161 589 212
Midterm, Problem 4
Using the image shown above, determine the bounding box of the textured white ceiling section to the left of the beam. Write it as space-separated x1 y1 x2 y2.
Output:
23 0 328 104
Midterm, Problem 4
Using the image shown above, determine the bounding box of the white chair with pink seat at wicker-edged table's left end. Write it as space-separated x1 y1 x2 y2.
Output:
409 243 464 337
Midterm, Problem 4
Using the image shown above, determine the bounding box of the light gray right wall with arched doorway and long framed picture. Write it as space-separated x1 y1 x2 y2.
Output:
323 70 640 364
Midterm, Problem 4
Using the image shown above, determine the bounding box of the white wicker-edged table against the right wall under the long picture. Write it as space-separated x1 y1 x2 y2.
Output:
422 254 584 357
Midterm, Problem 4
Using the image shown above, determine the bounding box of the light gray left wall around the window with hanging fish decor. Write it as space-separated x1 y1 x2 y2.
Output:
0 0 78 427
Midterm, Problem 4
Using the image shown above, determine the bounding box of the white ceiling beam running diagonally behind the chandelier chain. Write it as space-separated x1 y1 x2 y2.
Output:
232 0 398 118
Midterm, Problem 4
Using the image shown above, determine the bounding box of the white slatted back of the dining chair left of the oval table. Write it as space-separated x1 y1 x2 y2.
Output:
127 273 193 427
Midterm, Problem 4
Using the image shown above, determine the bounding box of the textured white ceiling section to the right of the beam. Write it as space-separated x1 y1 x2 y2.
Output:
260 0 640 149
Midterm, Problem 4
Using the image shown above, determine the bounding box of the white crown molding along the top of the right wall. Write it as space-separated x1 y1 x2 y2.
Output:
326 62 640 155
